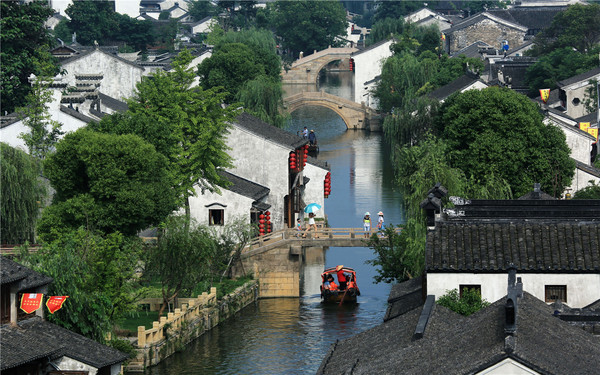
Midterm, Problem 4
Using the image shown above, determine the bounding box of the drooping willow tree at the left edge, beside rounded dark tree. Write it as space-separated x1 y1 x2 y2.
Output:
0 142 45 244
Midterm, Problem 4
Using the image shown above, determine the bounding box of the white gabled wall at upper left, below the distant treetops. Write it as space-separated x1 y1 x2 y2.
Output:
62 50 144 100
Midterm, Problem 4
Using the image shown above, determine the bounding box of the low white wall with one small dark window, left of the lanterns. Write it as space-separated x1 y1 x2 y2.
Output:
188 188 253 226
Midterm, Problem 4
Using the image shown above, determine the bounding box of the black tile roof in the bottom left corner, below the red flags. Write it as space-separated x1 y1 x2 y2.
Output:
0 317 128 370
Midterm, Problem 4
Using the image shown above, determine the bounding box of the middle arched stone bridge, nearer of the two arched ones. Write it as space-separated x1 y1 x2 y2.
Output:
283 91 379 131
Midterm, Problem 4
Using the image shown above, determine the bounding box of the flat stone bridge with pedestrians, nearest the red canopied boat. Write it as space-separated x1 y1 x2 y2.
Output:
234 228 398 298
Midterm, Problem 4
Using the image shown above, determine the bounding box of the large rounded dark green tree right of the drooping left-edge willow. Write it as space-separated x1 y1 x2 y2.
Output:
38 128 176 242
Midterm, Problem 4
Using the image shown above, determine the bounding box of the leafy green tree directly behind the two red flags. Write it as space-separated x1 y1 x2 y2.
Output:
21 228 142 343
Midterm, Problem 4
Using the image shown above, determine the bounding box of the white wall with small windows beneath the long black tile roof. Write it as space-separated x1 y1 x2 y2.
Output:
427 272 600 308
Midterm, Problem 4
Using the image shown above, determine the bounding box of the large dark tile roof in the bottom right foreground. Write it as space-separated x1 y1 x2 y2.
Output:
317 292 600 375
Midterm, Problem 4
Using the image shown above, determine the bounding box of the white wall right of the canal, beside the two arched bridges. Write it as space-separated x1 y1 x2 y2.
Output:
352 40 392 107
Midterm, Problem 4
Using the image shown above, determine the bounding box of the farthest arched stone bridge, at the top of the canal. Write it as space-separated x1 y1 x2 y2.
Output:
281 47 358 84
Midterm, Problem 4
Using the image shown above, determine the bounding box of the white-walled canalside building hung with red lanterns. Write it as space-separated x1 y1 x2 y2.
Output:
190 113 328 231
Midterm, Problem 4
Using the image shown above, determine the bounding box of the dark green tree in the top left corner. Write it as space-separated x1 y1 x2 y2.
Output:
0 1 59 112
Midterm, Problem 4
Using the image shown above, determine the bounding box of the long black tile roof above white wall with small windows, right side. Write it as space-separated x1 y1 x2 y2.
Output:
425 221 600 273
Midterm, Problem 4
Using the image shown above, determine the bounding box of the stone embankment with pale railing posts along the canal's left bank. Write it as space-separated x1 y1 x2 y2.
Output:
125 280 258 372
